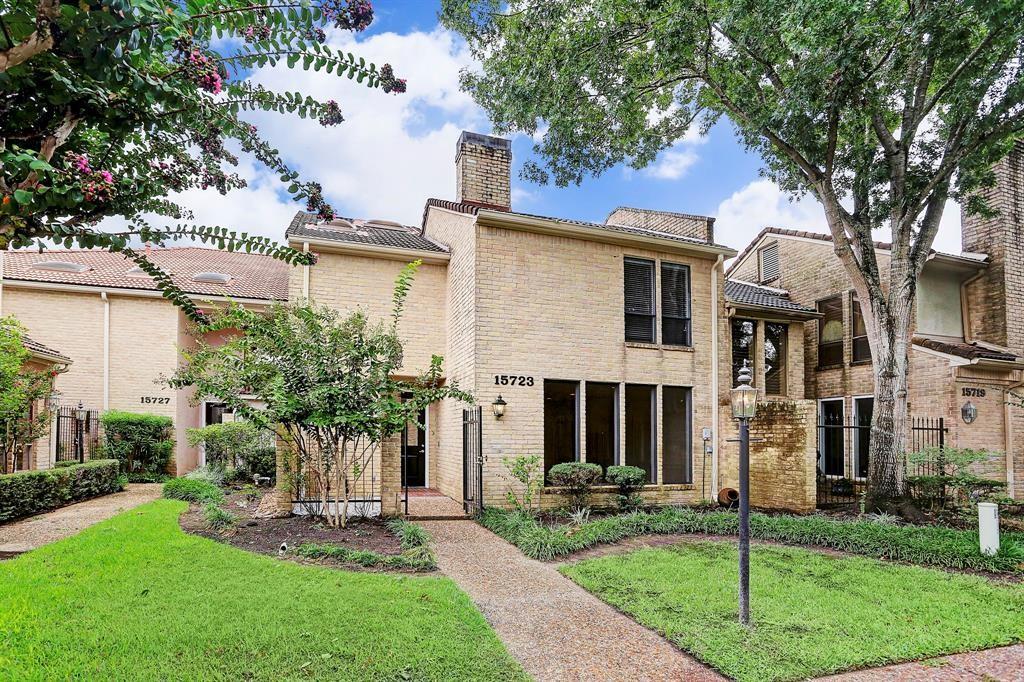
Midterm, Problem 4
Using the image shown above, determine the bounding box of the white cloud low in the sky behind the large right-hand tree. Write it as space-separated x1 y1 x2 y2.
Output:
715 179 961 254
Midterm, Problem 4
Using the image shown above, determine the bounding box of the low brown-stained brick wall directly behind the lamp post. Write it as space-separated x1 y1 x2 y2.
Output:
721 399 817 513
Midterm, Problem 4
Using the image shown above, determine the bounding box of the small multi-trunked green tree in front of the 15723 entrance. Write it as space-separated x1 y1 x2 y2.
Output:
169 261 472 526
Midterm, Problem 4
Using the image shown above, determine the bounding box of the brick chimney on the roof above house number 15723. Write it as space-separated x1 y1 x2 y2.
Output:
455 131 512 211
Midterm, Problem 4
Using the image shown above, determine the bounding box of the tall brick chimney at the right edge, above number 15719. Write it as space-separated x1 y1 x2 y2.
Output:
961 140 1024 352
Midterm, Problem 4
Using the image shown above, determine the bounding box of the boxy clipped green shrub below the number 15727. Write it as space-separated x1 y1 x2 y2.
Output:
99 411 174 482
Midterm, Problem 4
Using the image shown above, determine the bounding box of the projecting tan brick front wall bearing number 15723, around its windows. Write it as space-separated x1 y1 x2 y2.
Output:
471 220 728 505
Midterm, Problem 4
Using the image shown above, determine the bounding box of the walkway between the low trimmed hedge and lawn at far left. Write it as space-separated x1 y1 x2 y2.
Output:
0 483 162 559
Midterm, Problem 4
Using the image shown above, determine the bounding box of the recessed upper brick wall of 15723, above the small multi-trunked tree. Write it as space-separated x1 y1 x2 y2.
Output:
289 251 447 376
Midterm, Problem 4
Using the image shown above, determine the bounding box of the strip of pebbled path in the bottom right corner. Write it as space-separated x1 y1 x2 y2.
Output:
819 644 1024 682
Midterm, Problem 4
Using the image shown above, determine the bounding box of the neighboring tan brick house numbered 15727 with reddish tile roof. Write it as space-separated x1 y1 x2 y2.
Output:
0 247 289 474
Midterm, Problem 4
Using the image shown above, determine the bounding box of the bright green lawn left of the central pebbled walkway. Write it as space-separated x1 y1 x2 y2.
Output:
0 501 525 680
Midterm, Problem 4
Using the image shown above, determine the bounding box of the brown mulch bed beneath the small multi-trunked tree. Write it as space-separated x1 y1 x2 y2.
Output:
178 492 401 571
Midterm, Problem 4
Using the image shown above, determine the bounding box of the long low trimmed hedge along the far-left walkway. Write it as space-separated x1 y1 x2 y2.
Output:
0 460 122 523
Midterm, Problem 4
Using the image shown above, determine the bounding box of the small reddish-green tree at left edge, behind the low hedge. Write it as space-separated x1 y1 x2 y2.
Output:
0 316 62 473
